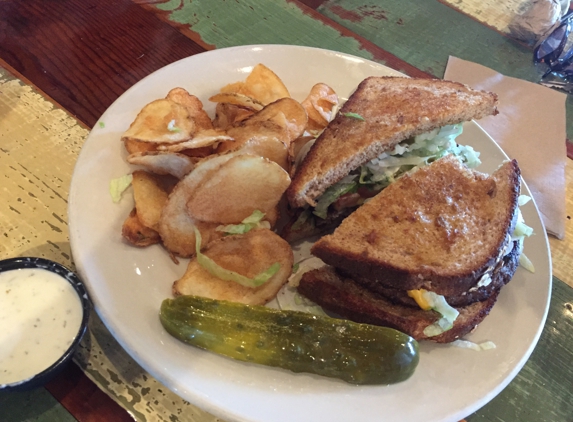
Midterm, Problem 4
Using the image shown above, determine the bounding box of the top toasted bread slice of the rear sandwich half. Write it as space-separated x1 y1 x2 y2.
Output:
287 77 497 208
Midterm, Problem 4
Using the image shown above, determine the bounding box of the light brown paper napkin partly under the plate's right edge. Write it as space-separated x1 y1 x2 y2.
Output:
444 56 567 239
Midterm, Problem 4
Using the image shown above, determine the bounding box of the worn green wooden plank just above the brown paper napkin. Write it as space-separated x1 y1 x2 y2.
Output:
308 0 537 80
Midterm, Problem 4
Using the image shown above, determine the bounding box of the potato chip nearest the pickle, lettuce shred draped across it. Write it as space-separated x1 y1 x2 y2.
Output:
173 229 294 305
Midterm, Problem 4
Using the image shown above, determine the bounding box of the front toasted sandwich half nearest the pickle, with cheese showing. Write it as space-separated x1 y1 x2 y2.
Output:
298 154 529 342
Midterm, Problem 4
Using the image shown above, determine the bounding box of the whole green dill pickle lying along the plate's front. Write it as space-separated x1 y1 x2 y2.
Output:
159 296 419 384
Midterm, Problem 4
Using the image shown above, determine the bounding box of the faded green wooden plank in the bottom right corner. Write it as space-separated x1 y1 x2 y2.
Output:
467 277 573 422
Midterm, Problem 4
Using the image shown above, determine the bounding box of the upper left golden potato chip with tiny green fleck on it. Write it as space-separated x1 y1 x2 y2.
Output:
121 99 196 143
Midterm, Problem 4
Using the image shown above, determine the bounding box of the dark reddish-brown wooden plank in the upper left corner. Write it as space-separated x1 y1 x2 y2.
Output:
0 0 205 127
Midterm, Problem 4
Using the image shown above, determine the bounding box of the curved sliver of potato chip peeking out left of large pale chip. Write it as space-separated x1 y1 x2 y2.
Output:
158 153 245 257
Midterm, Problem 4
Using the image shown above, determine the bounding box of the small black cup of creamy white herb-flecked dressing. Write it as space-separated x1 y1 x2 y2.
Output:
0 257 90 391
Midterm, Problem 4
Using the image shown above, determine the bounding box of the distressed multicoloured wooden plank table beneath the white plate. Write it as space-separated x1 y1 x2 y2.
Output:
0 0 573 421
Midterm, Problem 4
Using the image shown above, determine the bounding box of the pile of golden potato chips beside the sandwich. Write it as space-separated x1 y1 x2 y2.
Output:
121 64 338 304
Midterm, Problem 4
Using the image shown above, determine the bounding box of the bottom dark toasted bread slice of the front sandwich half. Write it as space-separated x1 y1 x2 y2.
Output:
298 266 499 343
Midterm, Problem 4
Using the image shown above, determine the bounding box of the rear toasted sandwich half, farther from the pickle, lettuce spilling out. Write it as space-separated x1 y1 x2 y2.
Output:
283 77 497 240
